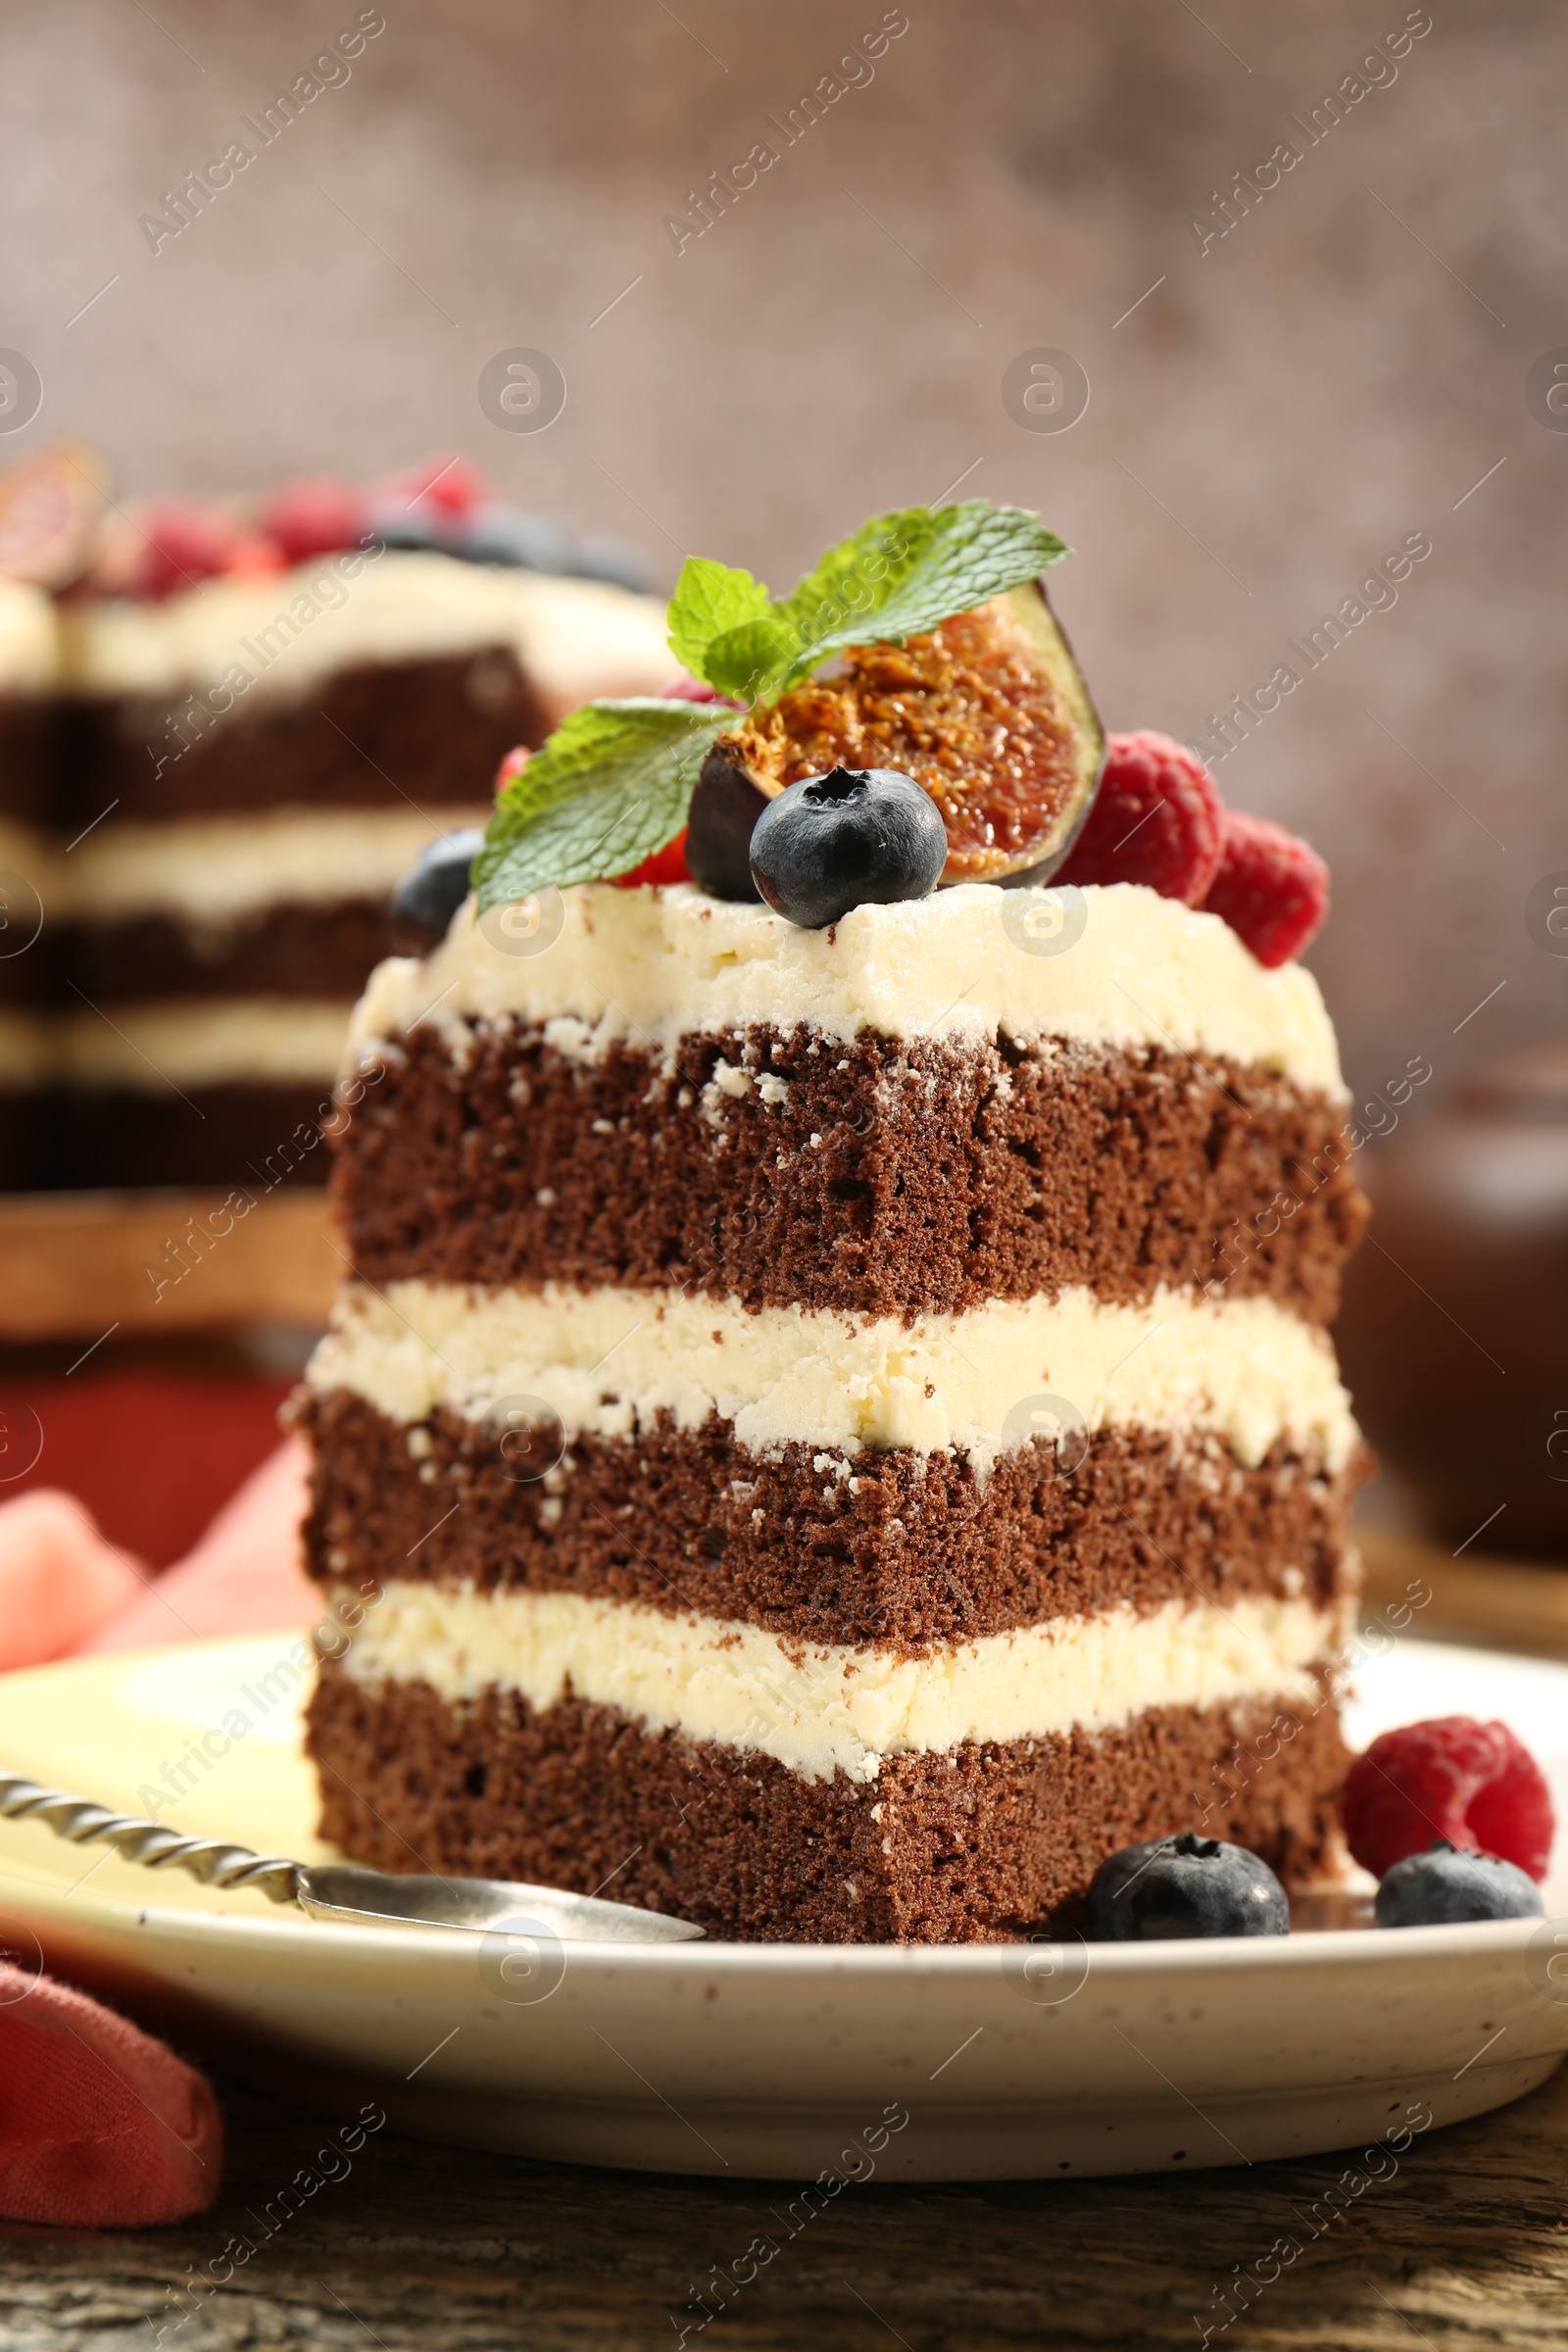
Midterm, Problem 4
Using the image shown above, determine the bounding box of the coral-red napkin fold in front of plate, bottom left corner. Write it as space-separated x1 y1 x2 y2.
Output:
0 1962 223 2230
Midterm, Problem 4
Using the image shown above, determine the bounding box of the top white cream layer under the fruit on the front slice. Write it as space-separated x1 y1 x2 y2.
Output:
353 882 1343 1096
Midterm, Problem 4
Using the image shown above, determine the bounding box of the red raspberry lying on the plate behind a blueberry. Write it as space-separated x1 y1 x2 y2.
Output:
1340 1715 1556 1880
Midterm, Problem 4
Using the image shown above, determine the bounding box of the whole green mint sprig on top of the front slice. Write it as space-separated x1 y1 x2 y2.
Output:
472 499 1072 907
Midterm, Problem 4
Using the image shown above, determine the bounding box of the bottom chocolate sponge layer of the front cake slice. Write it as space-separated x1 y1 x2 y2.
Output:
308 1665 1348 1942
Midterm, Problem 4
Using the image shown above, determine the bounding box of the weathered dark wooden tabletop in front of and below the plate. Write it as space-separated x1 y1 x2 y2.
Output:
0 2072 1568 2352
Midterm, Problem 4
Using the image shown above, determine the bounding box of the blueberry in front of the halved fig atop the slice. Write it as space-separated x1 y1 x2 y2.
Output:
750 766 948 931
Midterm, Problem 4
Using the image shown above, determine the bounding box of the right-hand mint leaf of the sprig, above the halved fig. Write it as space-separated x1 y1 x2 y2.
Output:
766 499 1072 692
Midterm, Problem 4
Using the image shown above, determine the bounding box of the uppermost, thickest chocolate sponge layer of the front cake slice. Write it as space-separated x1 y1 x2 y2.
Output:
334 1023 1366 1324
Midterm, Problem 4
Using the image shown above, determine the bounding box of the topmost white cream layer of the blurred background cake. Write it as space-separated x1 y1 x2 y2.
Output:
64 548 679 719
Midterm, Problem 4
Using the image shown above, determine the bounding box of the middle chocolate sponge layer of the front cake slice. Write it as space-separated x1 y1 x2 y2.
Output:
296 1390 1359 1656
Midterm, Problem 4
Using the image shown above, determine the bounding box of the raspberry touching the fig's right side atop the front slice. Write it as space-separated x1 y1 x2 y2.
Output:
1055 727 1225 906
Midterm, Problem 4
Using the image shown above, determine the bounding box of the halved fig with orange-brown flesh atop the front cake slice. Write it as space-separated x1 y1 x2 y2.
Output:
686 581 1104 896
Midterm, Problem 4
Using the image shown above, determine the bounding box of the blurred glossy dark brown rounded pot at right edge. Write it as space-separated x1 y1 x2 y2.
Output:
1340 1040 1568 1562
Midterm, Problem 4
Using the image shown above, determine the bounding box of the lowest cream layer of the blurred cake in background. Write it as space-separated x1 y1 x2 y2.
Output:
54 998 348 1103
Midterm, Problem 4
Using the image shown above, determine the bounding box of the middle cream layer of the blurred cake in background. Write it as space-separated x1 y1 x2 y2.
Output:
49 807 489 927
